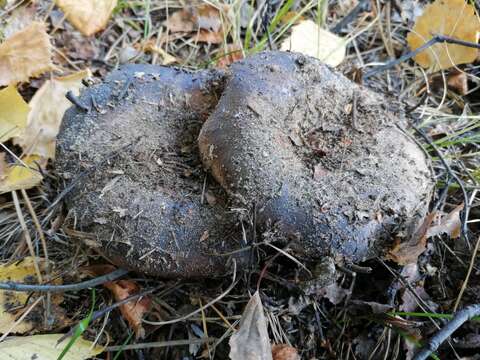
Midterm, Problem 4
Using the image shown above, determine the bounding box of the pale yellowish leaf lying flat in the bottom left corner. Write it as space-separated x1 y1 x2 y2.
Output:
0 334 104 360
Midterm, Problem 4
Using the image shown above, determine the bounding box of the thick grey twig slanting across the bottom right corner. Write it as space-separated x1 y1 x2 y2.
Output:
413 304 480 360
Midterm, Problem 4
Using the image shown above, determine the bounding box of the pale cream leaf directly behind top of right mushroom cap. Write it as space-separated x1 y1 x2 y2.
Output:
280 20 346 66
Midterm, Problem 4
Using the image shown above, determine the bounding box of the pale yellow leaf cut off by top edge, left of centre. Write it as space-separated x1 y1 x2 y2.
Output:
55 0 117 36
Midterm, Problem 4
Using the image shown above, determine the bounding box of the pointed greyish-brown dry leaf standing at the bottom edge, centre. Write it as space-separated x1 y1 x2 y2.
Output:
229 291 272 360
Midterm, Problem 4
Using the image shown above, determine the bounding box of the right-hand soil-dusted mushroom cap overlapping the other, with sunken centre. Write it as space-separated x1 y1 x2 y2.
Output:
199 52 433 261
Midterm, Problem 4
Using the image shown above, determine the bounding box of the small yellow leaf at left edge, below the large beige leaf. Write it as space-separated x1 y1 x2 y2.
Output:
0 155 46 194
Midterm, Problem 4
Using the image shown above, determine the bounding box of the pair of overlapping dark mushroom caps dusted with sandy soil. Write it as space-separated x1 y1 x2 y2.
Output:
57 52 433 277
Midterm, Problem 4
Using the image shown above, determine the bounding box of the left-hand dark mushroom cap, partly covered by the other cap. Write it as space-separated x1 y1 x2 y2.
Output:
56 65 245 278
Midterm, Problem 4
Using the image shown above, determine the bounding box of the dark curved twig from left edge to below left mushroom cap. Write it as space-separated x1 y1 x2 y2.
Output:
0 269 128 293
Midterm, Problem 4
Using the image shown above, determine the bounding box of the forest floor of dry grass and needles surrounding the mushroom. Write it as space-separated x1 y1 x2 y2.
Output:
0 0 480 360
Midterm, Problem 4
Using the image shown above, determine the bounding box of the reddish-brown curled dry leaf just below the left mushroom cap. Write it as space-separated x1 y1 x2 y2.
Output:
105 280 152 339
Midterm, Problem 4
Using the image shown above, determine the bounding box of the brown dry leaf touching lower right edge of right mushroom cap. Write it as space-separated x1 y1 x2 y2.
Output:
386 212 435 265
